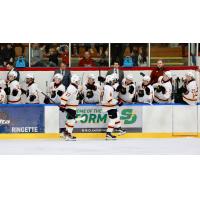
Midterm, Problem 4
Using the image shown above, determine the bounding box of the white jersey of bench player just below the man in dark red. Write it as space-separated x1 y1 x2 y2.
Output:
153 76 172 103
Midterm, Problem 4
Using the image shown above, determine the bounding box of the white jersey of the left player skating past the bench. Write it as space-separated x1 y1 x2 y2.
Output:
61 84 79 110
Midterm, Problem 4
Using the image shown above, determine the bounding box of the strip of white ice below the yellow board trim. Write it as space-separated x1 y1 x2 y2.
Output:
0 138 200 155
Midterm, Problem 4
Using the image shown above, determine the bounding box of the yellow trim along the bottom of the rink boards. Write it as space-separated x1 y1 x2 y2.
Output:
0 133 200 139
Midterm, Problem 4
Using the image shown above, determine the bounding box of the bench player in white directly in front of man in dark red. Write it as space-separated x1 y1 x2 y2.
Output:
153 71 172 103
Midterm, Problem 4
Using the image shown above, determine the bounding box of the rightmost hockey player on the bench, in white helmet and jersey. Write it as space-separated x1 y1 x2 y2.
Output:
182 72 198 105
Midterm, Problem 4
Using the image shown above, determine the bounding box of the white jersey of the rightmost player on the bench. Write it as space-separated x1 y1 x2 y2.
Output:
183 80 198 105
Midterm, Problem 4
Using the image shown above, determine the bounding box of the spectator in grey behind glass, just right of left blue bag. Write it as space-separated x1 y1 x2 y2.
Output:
31 43 44 67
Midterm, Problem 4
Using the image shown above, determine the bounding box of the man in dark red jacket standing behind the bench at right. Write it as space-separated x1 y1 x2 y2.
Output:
150 60 167 85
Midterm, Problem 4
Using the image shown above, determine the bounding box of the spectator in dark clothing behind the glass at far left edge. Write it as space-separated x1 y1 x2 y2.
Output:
1 44 15 66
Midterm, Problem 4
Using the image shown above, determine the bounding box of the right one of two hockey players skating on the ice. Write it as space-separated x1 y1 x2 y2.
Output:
102 75 126 139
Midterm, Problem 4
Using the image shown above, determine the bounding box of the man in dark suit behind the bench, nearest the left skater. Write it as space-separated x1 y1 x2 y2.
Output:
54 62 71 89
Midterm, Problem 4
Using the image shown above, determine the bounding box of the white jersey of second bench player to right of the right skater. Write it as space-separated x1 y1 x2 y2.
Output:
137 83 154 104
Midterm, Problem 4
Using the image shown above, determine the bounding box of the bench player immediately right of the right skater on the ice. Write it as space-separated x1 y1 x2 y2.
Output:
119 75 136 103
